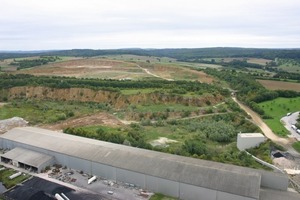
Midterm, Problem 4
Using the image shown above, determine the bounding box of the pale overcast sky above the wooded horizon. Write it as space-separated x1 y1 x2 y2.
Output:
0 0 300 51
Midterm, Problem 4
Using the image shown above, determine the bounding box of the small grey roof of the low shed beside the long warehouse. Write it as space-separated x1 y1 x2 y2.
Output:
1 147 53 168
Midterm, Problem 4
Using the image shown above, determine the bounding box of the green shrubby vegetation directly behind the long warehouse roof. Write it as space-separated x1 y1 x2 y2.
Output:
64 113 263 168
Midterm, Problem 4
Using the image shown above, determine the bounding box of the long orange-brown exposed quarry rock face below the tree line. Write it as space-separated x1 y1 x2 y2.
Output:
7 86 224 108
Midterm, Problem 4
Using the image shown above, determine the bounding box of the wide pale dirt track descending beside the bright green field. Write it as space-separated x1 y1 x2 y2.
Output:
232 97 294 146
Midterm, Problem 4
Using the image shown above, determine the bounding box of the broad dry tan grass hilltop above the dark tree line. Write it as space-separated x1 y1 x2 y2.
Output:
15 58 213 83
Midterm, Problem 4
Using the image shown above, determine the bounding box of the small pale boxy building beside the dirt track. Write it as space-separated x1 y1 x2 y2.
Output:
237 133 266 151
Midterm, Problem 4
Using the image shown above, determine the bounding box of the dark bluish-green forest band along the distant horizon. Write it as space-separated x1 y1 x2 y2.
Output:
0 47 300 61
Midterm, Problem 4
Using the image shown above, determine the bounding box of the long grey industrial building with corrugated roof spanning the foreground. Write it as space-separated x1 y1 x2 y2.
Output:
0 127 299 200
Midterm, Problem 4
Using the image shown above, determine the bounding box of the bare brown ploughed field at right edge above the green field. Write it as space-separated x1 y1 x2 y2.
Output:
257 80 300 92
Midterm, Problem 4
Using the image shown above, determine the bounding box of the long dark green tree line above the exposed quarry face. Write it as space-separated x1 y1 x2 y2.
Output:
0 74 229 95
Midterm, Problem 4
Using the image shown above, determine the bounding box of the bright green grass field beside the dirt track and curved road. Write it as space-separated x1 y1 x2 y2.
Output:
259 97 300 136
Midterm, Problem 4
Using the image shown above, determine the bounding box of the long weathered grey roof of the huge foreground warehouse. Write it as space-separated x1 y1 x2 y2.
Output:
0 127 261 199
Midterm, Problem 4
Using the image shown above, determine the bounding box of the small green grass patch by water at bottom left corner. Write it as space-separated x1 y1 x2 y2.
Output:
0 169 30 189
